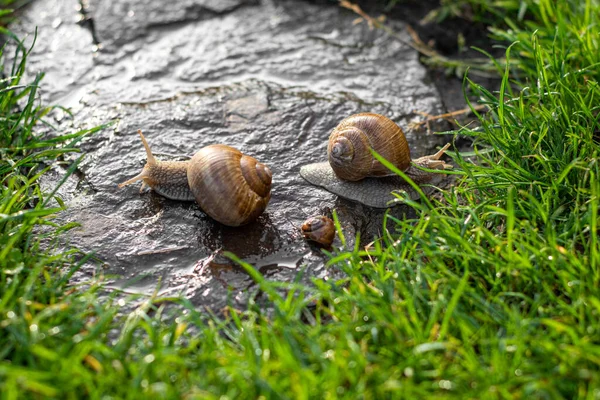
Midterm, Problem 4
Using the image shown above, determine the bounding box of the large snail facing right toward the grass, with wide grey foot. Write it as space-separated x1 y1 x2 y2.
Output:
300 113 452 208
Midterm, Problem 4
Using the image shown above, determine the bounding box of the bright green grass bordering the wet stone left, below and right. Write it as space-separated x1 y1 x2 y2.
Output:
0 1 600 399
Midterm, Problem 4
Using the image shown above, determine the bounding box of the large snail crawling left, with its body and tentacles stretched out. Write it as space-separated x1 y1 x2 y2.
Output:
119 130 272 226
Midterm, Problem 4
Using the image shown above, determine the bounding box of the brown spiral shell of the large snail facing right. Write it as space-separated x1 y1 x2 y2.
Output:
327 113 410 181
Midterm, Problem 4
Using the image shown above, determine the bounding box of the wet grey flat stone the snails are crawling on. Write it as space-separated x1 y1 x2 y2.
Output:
14 0 452 309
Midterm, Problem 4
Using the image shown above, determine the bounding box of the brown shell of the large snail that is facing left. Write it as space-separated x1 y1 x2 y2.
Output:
187 144 272 226
